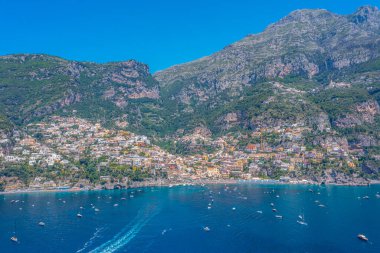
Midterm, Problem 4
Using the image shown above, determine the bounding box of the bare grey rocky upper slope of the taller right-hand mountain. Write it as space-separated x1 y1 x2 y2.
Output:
155 7 380 103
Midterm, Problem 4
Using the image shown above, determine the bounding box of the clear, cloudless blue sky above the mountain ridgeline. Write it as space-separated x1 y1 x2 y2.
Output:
0 0 380 72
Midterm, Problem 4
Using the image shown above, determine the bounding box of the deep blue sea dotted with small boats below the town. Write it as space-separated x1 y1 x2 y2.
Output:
0 183 380 253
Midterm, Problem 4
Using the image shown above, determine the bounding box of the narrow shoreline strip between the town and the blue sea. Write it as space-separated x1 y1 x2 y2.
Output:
0 179 380 195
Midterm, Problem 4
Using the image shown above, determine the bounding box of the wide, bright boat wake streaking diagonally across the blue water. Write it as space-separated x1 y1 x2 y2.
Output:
90 206 159 253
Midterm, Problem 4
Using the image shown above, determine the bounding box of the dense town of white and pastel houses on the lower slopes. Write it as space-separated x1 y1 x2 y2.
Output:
0 116 370 191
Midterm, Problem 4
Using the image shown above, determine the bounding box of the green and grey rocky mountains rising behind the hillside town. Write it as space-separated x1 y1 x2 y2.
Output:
0 6 380 182
